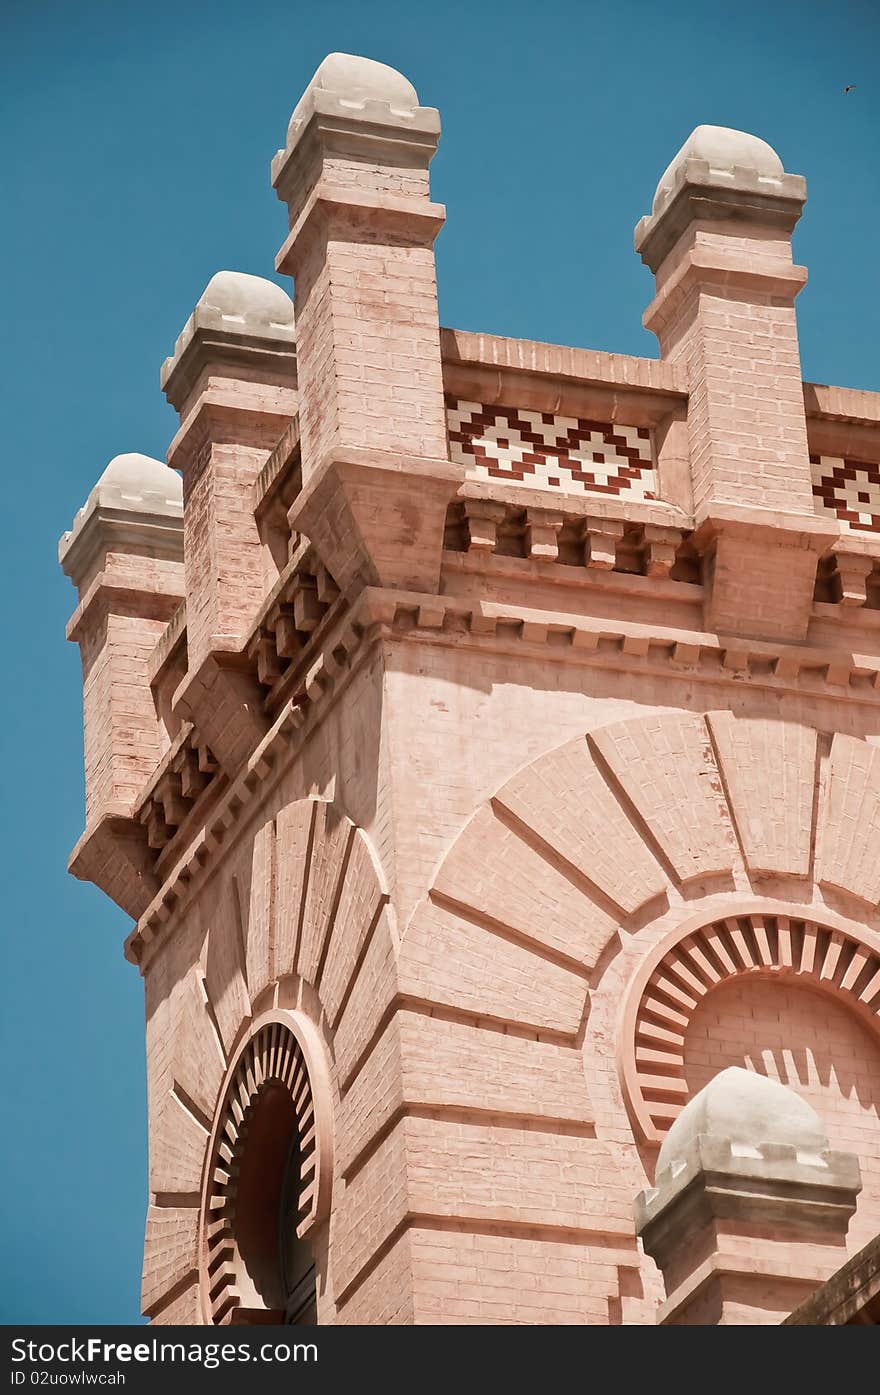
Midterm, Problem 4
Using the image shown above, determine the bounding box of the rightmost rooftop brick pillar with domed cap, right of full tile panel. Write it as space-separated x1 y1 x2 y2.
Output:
636 126 834 640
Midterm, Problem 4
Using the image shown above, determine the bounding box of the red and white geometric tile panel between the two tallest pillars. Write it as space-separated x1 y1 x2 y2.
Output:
446 398 657 499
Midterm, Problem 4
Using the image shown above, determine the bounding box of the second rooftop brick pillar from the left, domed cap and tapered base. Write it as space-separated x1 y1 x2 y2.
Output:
162 271 297 774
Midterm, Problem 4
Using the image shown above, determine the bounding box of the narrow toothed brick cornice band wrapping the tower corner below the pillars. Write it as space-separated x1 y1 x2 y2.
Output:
126 566 880 968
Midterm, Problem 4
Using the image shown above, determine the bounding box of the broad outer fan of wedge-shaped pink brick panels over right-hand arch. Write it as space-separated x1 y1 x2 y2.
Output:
400 711 880 1030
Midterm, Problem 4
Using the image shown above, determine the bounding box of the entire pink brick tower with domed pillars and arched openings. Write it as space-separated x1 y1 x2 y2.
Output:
60 54 880 1324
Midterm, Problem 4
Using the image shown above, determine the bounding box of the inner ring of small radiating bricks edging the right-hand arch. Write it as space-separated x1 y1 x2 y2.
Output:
618 903 880 1144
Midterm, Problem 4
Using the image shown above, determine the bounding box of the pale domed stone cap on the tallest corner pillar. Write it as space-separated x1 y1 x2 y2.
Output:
272 53 439 183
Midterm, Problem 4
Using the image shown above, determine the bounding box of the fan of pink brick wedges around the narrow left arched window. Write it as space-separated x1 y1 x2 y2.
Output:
142 798 395 1322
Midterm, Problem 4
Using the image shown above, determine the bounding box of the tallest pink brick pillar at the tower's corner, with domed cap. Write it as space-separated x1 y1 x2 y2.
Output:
272 54 460 590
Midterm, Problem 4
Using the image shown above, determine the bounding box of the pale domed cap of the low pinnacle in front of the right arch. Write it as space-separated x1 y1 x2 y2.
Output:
657 1066 828 1177
